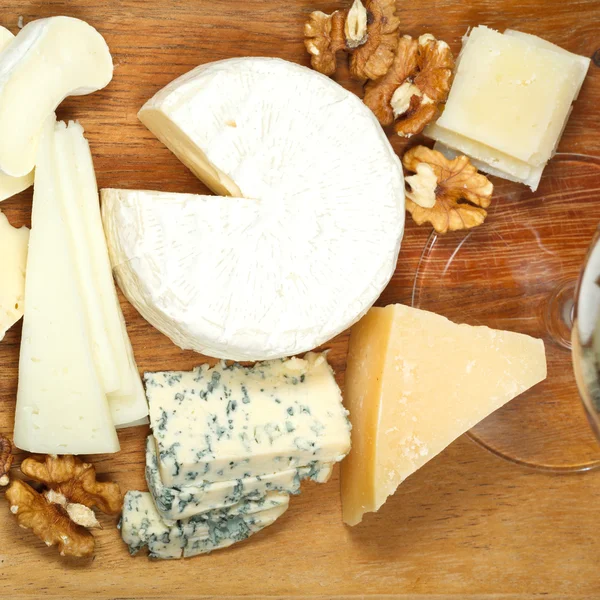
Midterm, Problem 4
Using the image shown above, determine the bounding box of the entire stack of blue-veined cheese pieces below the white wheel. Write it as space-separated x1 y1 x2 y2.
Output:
121 353 350 558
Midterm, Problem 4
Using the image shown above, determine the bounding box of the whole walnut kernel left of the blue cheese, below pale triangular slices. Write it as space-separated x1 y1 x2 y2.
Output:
6 455 123 558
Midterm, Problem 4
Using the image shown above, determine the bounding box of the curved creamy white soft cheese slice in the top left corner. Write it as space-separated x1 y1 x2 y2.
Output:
0 17 113 177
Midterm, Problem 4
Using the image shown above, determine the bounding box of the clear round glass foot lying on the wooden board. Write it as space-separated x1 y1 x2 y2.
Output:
412 154 600 471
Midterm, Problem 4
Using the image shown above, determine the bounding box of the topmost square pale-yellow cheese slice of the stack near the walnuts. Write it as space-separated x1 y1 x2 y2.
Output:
437 26 581 166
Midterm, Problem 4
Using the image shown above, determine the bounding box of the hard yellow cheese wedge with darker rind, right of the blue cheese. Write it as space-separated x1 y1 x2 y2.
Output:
342 304 546 525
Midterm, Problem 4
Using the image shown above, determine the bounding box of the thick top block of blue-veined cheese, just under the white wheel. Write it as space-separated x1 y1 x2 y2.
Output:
145 353 350 487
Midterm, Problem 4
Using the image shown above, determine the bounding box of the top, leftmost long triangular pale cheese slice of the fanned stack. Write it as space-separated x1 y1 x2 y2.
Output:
14 118 119 454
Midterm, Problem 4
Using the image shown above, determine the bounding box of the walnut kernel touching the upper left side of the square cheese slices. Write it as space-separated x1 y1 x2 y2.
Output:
364 34 454 137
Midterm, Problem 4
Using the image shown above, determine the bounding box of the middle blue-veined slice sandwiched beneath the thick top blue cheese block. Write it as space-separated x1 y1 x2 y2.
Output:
146 436 333 523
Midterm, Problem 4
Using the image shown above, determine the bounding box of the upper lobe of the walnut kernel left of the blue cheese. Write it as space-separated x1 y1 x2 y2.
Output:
21 455 123 515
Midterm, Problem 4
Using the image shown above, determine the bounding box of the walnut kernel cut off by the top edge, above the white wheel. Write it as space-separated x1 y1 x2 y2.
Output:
304 0 400 80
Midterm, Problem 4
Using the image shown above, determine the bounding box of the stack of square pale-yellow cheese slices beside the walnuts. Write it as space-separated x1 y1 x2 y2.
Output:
425 25 590 191
